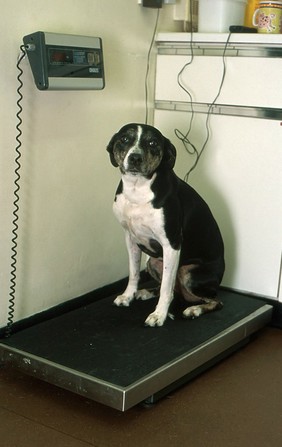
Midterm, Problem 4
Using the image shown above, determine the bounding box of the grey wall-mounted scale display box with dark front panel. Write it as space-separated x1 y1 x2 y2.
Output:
23 31 105 90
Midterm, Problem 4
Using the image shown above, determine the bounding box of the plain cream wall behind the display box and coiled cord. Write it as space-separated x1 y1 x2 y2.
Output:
0 0 179 326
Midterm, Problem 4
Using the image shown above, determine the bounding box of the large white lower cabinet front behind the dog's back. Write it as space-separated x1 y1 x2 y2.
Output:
155 110 282 298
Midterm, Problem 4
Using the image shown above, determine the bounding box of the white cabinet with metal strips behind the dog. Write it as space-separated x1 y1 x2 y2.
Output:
155 34 282 301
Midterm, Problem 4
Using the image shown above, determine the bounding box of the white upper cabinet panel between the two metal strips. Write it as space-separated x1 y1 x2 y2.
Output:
155 55 282 108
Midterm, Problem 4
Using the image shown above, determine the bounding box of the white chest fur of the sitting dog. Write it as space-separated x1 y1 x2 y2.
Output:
113 174 165 248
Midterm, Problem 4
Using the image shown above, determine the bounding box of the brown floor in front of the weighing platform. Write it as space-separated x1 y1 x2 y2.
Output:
0 327 282 447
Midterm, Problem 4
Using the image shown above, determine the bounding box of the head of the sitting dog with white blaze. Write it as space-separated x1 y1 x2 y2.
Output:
107 123 176 177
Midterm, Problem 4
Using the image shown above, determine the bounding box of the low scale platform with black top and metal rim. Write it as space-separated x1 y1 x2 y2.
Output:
0 289 272 411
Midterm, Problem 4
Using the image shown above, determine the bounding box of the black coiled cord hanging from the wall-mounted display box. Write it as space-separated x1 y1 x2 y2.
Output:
5 45 26 337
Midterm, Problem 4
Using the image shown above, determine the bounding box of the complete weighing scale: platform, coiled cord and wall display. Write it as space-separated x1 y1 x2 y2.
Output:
0 31 272 411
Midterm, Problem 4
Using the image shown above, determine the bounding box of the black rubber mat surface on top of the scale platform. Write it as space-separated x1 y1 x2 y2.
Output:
2 290 264 387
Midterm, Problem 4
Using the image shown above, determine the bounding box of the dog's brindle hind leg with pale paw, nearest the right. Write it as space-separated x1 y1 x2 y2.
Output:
177 265 223 319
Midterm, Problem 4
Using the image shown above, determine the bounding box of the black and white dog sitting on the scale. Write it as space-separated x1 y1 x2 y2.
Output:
107 124 224 326
